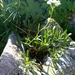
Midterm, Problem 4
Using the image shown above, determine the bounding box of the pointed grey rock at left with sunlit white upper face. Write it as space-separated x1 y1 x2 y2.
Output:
0 32 24 75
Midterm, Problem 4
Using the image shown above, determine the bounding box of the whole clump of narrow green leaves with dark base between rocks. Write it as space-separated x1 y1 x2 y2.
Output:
20 19 70 74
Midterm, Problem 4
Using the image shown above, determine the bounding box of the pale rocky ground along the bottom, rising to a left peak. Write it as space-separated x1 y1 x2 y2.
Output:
0 17 75 75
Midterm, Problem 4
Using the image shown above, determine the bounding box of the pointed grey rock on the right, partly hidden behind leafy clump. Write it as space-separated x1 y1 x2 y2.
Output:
42 18 75 75
